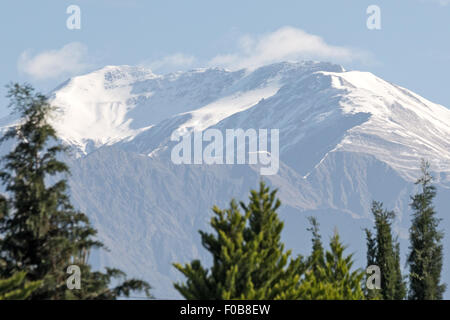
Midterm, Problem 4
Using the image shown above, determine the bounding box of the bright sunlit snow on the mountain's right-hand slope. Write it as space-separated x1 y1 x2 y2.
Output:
331 71 450 180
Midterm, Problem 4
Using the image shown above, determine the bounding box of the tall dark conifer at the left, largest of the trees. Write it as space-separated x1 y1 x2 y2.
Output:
0 84 149 299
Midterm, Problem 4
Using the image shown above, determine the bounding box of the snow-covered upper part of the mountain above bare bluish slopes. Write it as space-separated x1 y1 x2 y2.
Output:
3 61 450 175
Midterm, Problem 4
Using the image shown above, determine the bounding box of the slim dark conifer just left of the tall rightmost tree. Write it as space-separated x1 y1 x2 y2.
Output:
366 201 406 300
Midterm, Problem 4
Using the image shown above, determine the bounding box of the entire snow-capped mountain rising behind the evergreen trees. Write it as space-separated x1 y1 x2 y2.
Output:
0 62 450 298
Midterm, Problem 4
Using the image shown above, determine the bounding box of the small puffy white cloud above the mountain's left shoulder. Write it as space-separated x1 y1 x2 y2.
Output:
17 42 89 80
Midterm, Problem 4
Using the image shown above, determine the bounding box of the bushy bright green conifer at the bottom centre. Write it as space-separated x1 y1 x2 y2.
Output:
175 182 303 299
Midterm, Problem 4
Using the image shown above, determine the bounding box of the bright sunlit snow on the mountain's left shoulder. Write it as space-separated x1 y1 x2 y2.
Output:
52 66 157 153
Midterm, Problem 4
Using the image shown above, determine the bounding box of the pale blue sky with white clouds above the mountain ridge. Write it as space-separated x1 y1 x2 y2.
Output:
0 0 450 116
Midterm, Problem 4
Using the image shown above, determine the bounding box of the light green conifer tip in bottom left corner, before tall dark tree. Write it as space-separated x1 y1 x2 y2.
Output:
0 272 41 300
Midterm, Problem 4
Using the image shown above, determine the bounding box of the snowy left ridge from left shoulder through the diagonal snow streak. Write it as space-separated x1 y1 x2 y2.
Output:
52 63 341 154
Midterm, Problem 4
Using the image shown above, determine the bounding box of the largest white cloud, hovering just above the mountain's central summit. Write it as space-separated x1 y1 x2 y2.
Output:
209 27 370 69
